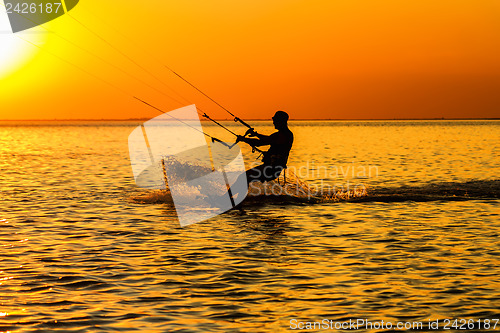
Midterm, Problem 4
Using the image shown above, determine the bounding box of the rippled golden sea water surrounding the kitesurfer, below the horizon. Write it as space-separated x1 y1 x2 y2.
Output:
0 121 500 332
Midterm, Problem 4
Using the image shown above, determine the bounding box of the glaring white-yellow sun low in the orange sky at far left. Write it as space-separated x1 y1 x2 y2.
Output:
0 1 41 79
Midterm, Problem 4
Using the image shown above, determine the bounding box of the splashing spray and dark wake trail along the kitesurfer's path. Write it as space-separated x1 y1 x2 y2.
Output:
130 159 500 206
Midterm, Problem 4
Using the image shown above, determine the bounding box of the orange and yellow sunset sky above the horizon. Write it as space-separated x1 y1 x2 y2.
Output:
0 0 500 119
